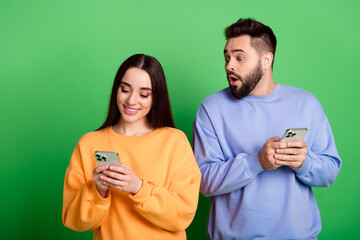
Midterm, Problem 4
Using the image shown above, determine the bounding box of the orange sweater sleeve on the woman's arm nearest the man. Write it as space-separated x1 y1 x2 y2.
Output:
130 133 200 231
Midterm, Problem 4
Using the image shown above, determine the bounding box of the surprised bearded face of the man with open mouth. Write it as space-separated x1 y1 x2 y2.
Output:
224 35 263 99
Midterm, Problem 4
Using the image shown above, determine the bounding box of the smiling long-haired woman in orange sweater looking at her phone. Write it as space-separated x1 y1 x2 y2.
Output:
62 54 200 240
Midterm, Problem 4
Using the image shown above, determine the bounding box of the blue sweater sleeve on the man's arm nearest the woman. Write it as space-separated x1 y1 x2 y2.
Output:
193 106 264 197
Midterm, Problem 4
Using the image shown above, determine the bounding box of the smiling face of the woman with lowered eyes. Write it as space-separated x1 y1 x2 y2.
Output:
117 68 152 124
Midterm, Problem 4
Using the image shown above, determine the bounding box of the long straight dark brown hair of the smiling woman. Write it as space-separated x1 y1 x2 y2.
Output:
97 54 175 130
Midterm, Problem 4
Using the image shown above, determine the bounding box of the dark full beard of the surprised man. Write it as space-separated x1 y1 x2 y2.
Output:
227 62 264 100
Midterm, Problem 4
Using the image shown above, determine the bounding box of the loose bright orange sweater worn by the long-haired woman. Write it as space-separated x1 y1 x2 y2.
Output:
62 128 200 240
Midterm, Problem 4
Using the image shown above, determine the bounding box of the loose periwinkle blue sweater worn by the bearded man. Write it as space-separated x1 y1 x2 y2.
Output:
194 84 341 240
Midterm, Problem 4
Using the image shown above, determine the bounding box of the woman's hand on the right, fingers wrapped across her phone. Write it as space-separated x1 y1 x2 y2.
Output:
100 164 142 195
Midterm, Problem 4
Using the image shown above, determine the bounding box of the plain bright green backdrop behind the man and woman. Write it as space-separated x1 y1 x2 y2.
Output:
0 0 360 239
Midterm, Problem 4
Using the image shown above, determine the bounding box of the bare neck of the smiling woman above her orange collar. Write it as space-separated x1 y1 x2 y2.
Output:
113 118 155 136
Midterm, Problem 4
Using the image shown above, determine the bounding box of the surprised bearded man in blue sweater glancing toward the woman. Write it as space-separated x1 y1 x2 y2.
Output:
194 19 341 240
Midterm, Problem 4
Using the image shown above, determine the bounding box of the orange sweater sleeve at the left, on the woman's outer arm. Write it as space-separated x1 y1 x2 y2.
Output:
62 144 111 231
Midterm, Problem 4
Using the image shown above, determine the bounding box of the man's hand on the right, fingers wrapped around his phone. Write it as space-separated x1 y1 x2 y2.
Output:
274 141 307 170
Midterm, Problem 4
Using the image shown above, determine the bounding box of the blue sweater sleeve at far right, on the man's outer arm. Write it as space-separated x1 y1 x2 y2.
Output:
296 106 342 187
